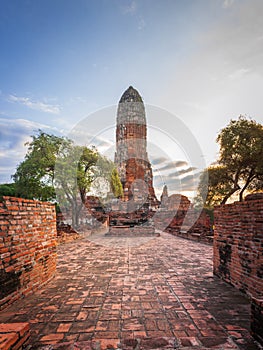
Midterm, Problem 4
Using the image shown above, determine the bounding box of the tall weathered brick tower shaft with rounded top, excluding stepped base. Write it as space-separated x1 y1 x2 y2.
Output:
115 86 158 207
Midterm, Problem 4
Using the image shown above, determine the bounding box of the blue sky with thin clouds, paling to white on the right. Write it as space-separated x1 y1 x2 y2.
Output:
0 0 263 197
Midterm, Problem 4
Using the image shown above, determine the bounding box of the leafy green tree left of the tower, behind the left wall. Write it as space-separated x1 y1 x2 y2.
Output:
12 130 122 228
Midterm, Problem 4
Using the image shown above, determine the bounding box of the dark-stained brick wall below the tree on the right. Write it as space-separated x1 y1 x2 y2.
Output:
214 199 263 298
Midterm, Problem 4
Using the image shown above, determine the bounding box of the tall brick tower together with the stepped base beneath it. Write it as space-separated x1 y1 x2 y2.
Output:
109 86 159 235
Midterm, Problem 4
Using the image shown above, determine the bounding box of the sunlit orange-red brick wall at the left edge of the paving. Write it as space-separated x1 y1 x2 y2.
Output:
0 197 57 309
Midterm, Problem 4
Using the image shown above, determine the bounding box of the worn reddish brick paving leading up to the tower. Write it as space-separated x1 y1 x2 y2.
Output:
0 233 259 350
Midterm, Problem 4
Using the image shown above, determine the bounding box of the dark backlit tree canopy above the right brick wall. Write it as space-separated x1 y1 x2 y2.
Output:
199 116 263 207
